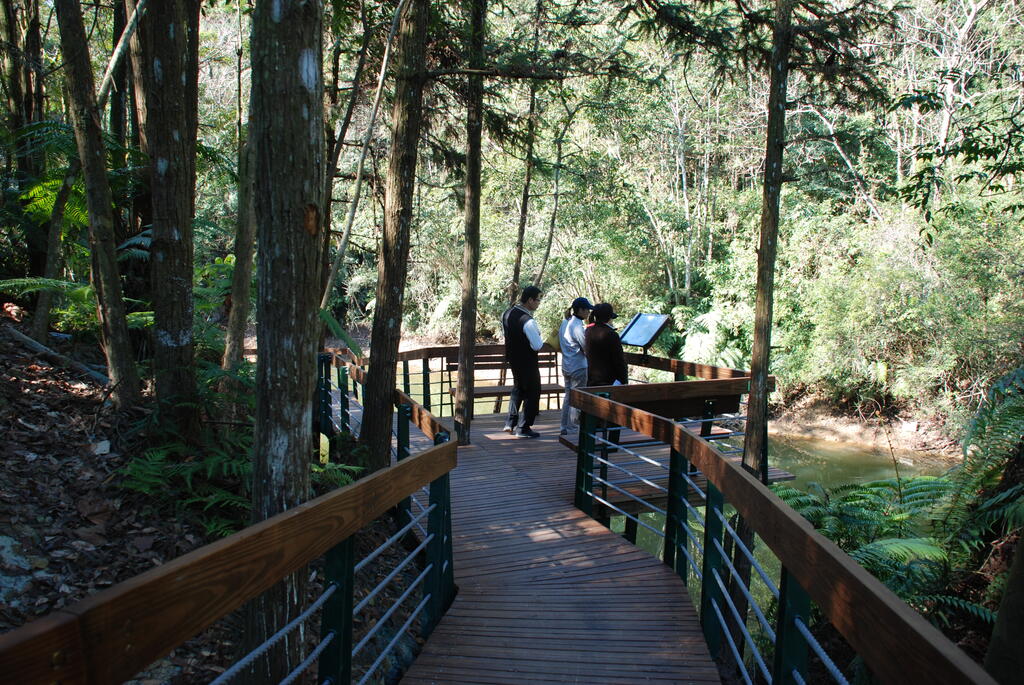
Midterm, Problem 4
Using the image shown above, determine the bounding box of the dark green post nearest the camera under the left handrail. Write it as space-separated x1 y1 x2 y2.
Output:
316 537 354 685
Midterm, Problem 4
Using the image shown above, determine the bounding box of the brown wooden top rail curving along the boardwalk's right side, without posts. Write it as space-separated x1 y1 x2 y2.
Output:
570 386 995 685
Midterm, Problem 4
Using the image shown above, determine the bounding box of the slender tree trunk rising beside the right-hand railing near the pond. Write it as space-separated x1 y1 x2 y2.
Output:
743 0 793 479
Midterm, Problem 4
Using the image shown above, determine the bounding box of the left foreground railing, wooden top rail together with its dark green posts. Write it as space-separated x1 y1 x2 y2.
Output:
0 348 457 685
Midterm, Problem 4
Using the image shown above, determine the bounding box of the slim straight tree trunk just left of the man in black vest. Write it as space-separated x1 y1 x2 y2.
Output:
455 0 487 444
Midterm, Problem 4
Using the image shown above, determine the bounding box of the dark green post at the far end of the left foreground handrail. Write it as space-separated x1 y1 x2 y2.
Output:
423 433 455 639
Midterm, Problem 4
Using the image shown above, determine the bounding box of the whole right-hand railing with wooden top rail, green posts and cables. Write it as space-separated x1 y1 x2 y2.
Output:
570 379 994 684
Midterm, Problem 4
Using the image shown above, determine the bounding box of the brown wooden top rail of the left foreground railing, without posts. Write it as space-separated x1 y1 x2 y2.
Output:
0 442 457 685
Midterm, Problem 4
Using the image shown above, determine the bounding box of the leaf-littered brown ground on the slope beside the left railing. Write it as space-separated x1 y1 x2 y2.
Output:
0 323 417 685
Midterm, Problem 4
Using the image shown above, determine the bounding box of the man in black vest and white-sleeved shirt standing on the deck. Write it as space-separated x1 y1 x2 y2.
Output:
502 286 544 437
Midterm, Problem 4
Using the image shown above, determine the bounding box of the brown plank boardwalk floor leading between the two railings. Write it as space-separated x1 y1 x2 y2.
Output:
402 411 720 683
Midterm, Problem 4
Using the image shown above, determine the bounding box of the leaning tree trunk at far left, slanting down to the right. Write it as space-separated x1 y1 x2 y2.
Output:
54 0 140 408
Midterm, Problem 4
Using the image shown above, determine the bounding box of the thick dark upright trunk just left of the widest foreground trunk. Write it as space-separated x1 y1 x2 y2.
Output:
135 0 199 436
